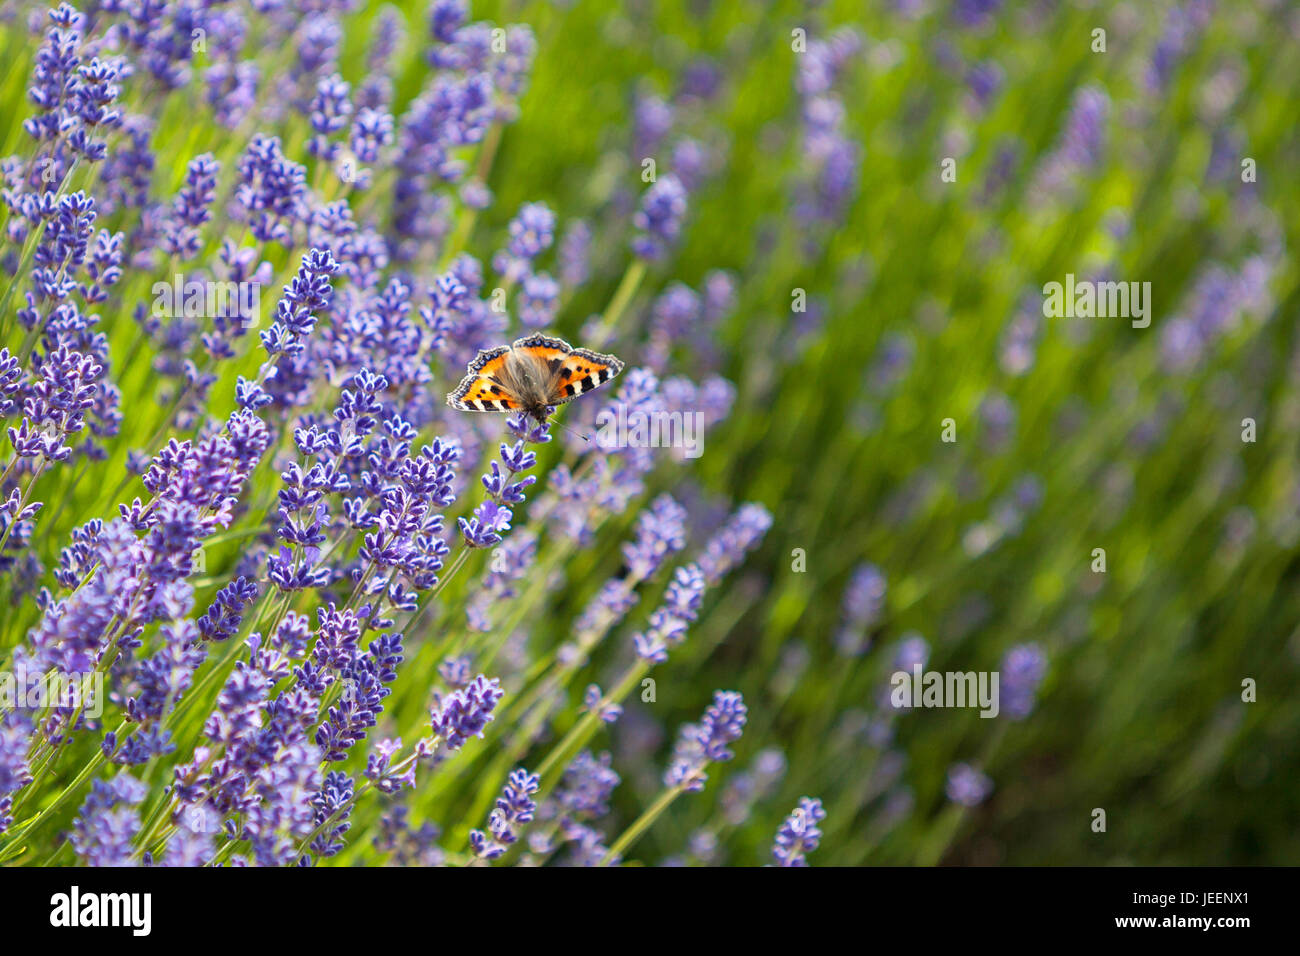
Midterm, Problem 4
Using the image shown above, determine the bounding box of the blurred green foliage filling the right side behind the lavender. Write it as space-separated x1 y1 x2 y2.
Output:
483 3 1300 864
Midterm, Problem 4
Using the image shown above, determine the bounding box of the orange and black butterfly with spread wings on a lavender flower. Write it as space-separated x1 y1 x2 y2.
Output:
447 332 623 423
